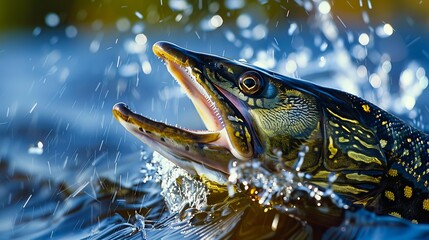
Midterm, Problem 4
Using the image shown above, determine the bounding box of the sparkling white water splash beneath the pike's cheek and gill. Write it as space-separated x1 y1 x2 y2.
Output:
228 146 349 220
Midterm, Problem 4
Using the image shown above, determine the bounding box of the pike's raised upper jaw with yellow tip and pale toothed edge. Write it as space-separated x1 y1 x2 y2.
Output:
153 42 255 160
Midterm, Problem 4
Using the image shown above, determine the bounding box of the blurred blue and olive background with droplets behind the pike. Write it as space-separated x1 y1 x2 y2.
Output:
0 0 429 237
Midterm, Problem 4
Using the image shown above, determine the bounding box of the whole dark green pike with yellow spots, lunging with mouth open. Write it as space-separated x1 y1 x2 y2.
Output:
113 42 429 222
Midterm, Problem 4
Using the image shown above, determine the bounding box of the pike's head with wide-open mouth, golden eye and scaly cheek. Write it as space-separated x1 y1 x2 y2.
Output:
113 42 320 182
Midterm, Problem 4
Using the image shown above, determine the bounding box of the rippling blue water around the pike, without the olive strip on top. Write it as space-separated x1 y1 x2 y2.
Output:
0 1 429 239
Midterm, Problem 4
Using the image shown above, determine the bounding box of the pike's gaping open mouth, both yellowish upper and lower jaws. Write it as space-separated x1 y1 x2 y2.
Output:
113 42 253 178
